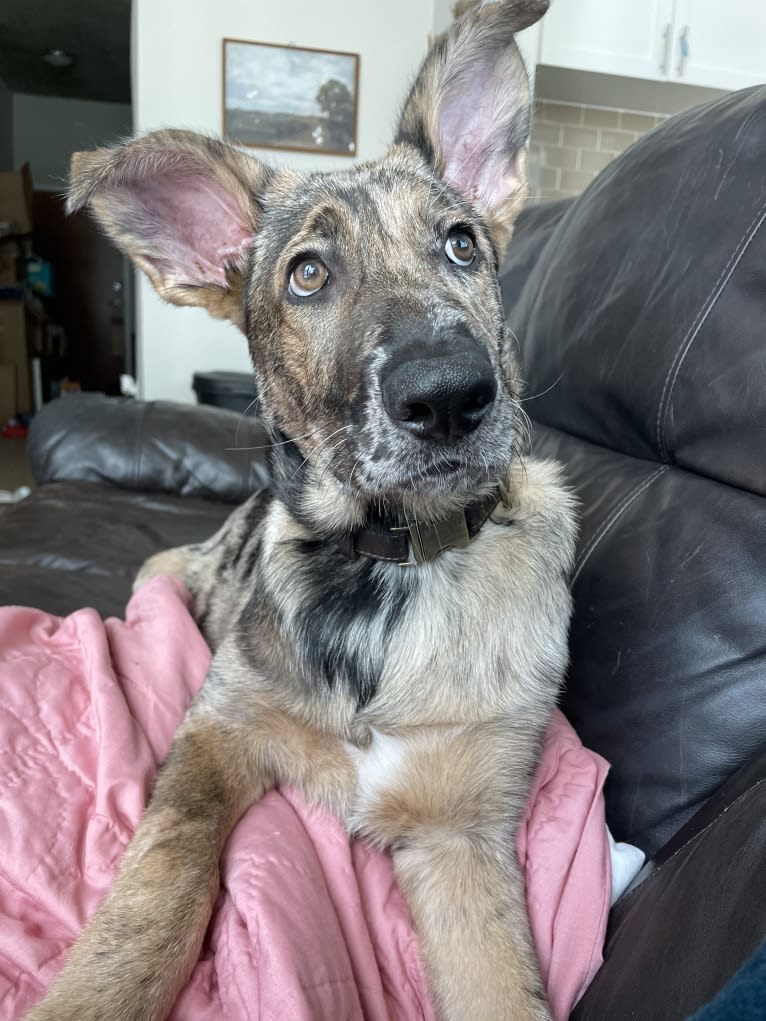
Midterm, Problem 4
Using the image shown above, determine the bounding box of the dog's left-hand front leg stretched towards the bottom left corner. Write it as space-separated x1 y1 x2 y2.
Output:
29 714 271 1021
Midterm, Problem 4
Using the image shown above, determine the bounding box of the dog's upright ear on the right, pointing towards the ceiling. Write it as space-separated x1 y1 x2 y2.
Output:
395 0 548 251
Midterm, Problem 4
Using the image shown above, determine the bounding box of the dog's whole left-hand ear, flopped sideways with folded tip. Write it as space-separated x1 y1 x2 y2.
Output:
67 131 272 330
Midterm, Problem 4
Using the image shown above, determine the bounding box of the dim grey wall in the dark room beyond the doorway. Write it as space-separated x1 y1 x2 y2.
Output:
13 92 133 191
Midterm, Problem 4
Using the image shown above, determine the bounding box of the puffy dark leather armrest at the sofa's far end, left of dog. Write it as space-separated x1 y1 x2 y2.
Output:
28 394 269 503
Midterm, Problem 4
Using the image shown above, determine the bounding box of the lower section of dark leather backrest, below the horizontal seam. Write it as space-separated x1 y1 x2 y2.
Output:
534 425 766 855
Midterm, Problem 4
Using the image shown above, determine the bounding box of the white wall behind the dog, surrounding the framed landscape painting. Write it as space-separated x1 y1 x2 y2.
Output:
133 0 434 400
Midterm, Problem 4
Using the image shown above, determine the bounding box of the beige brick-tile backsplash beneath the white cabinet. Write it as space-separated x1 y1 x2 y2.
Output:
529 99 667 202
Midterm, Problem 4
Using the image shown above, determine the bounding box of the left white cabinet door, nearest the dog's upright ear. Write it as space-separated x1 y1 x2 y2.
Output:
540 0 678 79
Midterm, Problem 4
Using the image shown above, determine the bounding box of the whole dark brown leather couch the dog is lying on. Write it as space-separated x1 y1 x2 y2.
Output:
0 83 766 1021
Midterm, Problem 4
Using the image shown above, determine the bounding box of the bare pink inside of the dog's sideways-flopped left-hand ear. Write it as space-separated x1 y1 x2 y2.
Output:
125 173 253 287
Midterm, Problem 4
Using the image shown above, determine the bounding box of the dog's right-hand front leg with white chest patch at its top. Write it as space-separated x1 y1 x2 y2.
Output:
360 720 550 1021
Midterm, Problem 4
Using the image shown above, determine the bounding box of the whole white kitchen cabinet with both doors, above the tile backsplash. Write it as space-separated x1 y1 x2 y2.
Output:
540 0 766 89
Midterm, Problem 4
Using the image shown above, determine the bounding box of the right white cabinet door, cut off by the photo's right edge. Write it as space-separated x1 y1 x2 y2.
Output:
670 0 766 89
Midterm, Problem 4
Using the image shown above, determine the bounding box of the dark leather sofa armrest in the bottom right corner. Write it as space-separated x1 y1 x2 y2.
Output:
571 747 766 1021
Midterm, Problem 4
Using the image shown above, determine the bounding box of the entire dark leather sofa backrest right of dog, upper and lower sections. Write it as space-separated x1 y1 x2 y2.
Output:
502 88 766 856
